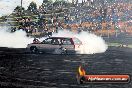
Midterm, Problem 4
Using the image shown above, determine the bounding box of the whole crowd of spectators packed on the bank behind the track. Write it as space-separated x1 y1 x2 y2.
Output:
11 2 132 35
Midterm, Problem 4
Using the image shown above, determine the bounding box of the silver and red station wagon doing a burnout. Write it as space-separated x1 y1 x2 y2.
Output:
27 37 82 54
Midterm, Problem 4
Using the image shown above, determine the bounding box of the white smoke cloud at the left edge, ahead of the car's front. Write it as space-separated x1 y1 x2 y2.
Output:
0 27 33 48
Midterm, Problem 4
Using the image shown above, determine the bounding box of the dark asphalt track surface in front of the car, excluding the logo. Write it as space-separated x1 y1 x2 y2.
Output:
0 47 132 88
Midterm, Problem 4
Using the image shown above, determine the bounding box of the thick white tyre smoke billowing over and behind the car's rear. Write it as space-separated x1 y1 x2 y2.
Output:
53 31 108 54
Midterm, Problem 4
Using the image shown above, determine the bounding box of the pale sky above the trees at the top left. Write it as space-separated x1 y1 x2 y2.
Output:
0 0 43 16
